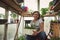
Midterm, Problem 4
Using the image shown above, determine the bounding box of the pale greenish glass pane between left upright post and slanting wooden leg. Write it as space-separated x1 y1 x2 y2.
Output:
7 24 17 40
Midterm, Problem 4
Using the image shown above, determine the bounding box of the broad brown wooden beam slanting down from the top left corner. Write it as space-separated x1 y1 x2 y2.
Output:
0 0 22 12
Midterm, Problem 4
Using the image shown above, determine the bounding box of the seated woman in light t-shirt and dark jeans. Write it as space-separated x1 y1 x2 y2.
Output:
26 11 46 40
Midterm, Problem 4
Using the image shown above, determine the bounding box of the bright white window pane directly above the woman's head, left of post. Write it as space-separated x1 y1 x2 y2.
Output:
24 0 38 11
